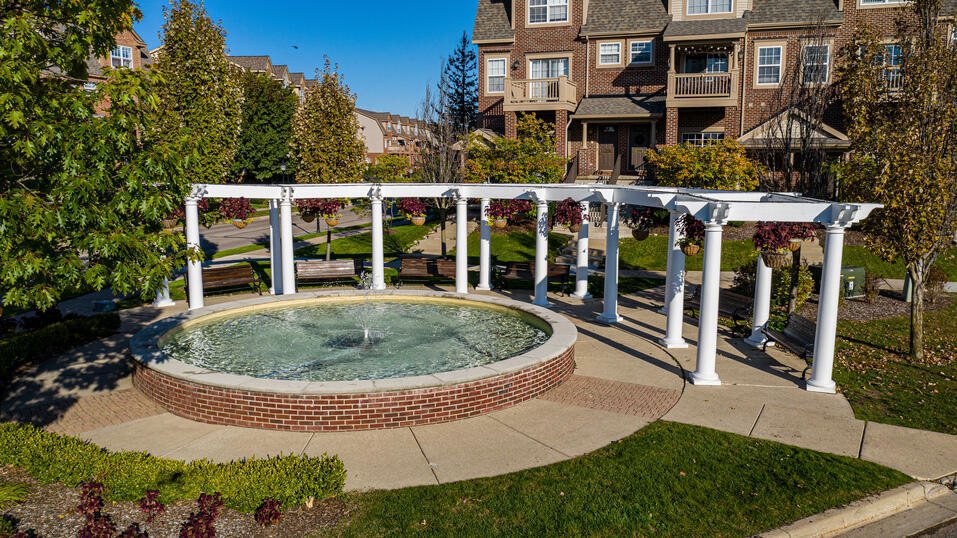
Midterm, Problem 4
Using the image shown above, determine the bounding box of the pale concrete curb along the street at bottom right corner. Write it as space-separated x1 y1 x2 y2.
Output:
758 482 951 538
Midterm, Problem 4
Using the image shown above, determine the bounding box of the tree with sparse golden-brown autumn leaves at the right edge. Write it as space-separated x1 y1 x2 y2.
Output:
840 0 957 360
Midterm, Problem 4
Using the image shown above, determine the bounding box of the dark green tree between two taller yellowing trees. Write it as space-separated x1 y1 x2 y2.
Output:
232 73 299 183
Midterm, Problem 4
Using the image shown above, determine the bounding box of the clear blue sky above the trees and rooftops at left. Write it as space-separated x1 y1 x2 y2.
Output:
136 0 477 116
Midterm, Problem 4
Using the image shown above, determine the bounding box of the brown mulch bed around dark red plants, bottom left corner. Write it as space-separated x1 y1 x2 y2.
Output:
0 466 350 538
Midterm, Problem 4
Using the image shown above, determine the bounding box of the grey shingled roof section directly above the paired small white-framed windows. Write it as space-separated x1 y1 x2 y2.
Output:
581 0 671 36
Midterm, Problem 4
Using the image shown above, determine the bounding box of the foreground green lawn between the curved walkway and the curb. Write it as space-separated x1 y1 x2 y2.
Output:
328 422 910 536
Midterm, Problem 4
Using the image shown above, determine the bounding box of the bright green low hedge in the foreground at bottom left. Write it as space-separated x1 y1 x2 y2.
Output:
0 422 346 513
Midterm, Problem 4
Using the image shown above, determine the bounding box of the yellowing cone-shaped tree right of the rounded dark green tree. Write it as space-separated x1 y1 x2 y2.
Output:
293 58 365 183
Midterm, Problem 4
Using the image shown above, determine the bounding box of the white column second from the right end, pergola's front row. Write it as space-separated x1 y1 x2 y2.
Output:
691 221 722 385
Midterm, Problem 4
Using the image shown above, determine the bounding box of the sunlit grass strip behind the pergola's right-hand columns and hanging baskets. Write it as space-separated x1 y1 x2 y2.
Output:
618 235 754 271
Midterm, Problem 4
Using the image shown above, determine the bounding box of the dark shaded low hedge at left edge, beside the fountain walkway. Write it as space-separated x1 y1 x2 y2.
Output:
0 312 120 387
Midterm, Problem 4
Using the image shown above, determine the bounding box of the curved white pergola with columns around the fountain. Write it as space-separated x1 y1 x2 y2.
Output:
174 183 880 393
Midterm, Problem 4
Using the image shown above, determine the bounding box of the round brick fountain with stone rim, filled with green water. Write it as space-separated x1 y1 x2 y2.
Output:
131 291 577 431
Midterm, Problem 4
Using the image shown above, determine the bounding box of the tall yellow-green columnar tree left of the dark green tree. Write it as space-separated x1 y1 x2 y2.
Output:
153 0 242 183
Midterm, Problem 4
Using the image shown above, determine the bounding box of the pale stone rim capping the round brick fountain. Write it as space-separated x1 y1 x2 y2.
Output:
130 290 578 395
